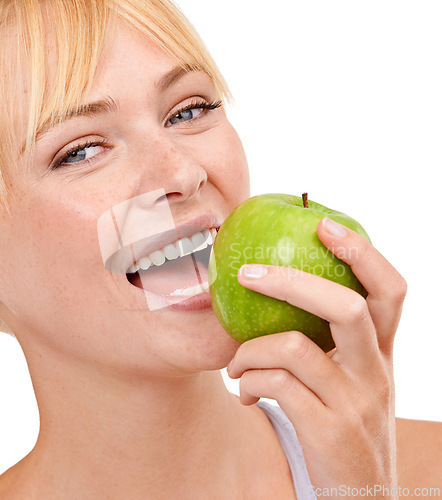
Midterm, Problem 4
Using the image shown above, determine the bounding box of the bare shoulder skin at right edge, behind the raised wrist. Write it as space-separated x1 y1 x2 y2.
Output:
396 418 442 494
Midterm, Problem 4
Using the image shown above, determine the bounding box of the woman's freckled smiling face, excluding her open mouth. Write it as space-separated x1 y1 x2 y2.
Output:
0 22 249 374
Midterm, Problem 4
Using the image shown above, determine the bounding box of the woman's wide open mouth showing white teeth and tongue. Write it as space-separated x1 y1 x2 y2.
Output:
126 228 218 301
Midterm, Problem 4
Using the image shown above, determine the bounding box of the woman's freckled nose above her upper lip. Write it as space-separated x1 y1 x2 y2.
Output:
139 137 207 208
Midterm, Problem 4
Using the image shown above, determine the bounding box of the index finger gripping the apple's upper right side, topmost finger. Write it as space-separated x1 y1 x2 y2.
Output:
317 218 407 353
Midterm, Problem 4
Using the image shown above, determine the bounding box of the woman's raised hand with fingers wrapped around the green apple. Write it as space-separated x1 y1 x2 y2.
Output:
228 219 406 498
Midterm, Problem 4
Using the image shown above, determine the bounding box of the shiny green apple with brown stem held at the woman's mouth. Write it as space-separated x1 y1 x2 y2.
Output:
209 194 370 352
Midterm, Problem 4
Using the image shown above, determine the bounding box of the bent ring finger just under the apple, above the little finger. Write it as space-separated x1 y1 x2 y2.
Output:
227 332 348 408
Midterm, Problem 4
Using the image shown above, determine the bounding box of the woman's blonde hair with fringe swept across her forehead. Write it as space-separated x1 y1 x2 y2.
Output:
0 0 231 336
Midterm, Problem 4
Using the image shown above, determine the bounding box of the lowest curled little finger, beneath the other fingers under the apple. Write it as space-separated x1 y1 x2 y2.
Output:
240 369 329 433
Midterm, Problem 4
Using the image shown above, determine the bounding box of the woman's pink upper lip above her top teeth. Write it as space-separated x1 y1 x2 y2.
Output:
125 214 223 273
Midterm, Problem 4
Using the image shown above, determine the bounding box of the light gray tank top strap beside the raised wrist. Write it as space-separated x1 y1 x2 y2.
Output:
256 400 316 500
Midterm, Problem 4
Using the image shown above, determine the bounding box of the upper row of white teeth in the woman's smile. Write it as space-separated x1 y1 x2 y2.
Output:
127 228 218 274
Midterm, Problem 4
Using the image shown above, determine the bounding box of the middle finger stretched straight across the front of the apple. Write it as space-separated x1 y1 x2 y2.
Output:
238 265 379 369
